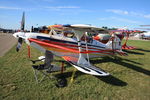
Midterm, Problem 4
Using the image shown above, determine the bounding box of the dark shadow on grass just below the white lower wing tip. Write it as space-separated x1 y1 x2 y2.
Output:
95 75 127 86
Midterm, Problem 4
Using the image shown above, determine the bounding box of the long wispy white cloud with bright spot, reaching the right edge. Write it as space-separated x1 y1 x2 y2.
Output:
105 9 150 18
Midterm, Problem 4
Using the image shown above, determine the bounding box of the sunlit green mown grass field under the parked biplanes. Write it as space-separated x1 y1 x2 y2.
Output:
0 40 150 100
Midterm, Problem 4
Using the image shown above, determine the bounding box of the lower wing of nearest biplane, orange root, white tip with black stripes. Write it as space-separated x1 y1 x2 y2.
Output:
62 56 109 76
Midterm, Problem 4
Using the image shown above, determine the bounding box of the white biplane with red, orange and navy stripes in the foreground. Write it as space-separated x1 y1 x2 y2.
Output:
13 12 127 85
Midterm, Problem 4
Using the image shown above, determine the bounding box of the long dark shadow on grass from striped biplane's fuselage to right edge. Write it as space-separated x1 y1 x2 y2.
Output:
91 57 150 76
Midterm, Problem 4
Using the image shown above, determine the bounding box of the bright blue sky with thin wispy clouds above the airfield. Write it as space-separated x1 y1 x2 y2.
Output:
0 0 150 29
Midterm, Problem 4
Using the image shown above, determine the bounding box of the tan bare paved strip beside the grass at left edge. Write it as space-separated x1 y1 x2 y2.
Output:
0 33 17 57
